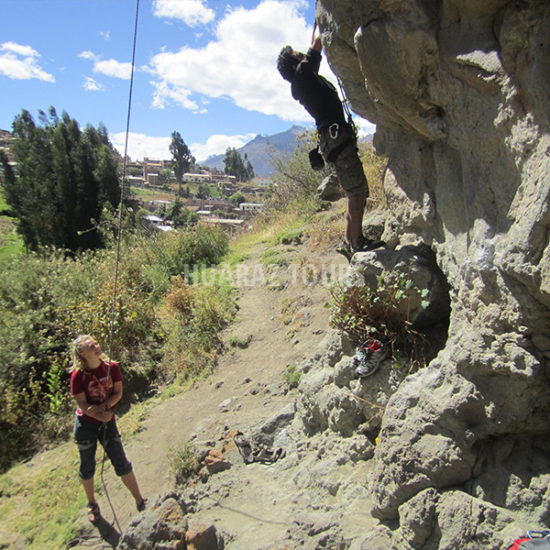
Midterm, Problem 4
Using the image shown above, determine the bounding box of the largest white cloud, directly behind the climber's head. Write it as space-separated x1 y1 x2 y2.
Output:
148 0 328 121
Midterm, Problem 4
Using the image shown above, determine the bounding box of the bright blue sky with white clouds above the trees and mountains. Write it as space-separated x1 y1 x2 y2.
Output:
0 0 376 161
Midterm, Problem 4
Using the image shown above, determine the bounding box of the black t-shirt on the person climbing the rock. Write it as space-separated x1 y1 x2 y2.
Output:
291 48 346 130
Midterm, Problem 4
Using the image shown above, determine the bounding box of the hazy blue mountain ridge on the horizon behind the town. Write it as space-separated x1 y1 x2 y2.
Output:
201 126 307 177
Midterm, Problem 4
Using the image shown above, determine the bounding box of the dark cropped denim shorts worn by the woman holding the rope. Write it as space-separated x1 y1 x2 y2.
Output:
74 415 132 479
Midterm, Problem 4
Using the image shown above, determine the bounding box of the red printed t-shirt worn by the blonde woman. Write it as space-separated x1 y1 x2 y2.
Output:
71 361 122 424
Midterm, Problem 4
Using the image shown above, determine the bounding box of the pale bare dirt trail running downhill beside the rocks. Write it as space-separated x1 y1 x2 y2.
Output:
90 247 347 548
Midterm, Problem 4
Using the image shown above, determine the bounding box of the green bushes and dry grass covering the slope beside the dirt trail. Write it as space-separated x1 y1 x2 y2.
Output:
0 123 383 548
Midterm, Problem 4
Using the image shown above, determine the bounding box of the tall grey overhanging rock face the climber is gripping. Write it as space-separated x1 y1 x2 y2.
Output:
314 0 550 548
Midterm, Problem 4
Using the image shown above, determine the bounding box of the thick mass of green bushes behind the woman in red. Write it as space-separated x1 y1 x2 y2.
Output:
0 225 233 469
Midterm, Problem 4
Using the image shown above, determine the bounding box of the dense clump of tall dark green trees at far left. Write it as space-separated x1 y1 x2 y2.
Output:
0 107 120 252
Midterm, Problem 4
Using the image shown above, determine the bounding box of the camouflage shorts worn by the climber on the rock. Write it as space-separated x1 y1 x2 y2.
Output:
319 124 369 197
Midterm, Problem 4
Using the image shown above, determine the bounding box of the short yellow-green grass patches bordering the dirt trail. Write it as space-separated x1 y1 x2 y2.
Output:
0 191 380 550
